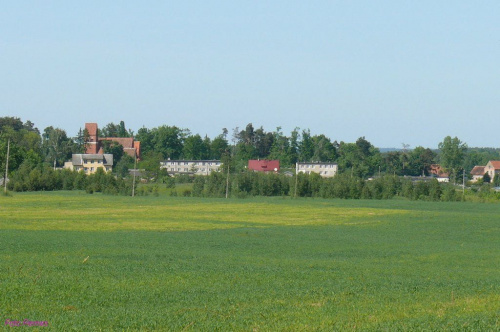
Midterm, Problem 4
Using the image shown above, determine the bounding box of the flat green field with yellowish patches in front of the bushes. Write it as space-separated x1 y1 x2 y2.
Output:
0 192 500 331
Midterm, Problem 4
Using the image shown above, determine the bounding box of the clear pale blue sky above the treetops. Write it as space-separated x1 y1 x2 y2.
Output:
0 0 500 147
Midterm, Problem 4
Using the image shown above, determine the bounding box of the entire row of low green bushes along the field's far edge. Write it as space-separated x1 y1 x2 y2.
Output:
9 164 494 201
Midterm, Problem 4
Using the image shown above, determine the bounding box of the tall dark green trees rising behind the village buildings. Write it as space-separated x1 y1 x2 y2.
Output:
0 117 500 195
